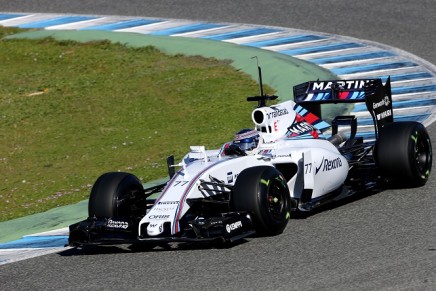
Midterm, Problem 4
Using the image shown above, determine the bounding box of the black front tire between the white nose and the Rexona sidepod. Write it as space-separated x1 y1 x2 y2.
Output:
230 166 291 235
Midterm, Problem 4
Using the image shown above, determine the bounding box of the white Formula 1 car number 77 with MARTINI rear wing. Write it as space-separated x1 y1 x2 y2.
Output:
69 70 432 246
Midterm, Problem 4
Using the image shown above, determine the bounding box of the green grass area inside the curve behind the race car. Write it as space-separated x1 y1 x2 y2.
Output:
0 27 271 221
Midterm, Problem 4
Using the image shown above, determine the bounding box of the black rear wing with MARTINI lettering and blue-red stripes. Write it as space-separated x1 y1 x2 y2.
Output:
294 78 394 136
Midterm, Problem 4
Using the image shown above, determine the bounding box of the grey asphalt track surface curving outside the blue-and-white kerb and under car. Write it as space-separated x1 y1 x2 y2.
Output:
0 0 436 290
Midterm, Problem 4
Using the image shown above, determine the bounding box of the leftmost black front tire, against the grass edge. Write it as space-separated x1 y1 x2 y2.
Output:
88 172 145 218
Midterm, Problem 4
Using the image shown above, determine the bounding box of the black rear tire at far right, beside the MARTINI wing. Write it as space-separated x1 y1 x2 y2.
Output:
374 122 432 187
